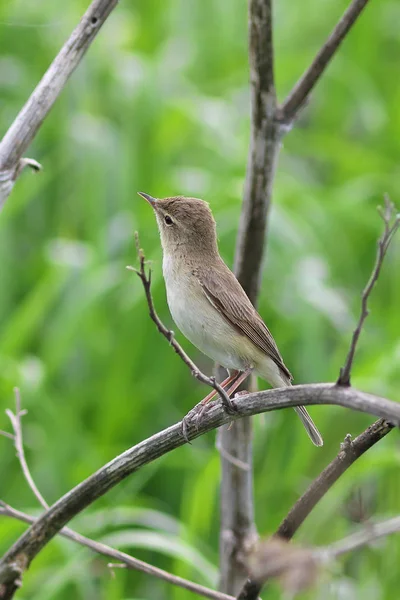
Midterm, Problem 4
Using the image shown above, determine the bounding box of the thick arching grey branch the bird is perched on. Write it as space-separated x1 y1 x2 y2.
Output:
0 383 400 600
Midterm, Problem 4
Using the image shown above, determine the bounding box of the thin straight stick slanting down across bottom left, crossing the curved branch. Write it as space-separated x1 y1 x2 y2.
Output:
0 501 234 600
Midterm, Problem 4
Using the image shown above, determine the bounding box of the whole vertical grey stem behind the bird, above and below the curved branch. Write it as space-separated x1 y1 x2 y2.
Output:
218 0 280 594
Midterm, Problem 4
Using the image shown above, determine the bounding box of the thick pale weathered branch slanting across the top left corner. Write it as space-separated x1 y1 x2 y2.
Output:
0 0 118 209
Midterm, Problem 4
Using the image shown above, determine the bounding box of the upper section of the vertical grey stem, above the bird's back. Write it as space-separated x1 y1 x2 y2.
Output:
234 0 280 304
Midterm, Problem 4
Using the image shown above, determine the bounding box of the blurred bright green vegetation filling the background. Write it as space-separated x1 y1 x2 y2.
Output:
0 0 400 600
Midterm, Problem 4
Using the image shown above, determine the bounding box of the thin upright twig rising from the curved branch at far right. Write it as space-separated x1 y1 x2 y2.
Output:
337 195 400 386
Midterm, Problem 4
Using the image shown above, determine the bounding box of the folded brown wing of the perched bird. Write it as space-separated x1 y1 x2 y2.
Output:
194 263 292 379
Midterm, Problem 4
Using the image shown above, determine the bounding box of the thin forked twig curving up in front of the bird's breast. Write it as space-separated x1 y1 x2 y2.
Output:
126 231 235 414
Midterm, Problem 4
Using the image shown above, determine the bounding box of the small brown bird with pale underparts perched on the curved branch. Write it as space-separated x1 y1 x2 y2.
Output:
139 192 323 446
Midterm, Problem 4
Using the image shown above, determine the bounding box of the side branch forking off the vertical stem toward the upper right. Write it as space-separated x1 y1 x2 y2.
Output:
277 0 368 124
